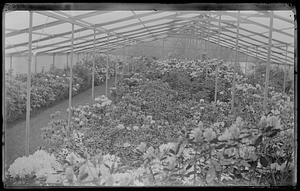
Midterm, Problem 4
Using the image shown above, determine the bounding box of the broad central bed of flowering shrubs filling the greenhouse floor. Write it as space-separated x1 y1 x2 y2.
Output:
7 57 294 186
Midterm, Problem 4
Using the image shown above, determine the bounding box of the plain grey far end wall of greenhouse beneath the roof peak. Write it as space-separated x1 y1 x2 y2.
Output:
113 38 256 62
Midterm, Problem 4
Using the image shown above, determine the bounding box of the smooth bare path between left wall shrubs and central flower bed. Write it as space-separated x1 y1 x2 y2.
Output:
3 78 114 167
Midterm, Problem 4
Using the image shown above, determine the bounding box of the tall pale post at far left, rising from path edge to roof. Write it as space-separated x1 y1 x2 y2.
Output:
25 11 33 156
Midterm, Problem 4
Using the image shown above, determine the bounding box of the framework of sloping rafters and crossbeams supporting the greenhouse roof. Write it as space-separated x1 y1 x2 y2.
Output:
5 10 295 65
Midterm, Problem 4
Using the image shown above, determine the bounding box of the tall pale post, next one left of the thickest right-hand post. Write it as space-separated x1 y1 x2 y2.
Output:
231 11 240 118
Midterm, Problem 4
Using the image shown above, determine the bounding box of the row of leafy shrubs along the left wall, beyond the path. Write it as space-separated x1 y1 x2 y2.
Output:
5 55 122 122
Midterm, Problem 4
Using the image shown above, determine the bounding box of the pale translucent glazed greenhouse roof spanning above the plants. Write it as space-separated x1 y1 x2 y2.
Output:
5 10 295 64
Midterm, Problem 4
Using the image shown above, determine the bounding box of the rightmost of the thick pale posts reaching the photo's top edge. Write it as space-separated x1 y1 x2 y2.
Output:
263 11 273 112
